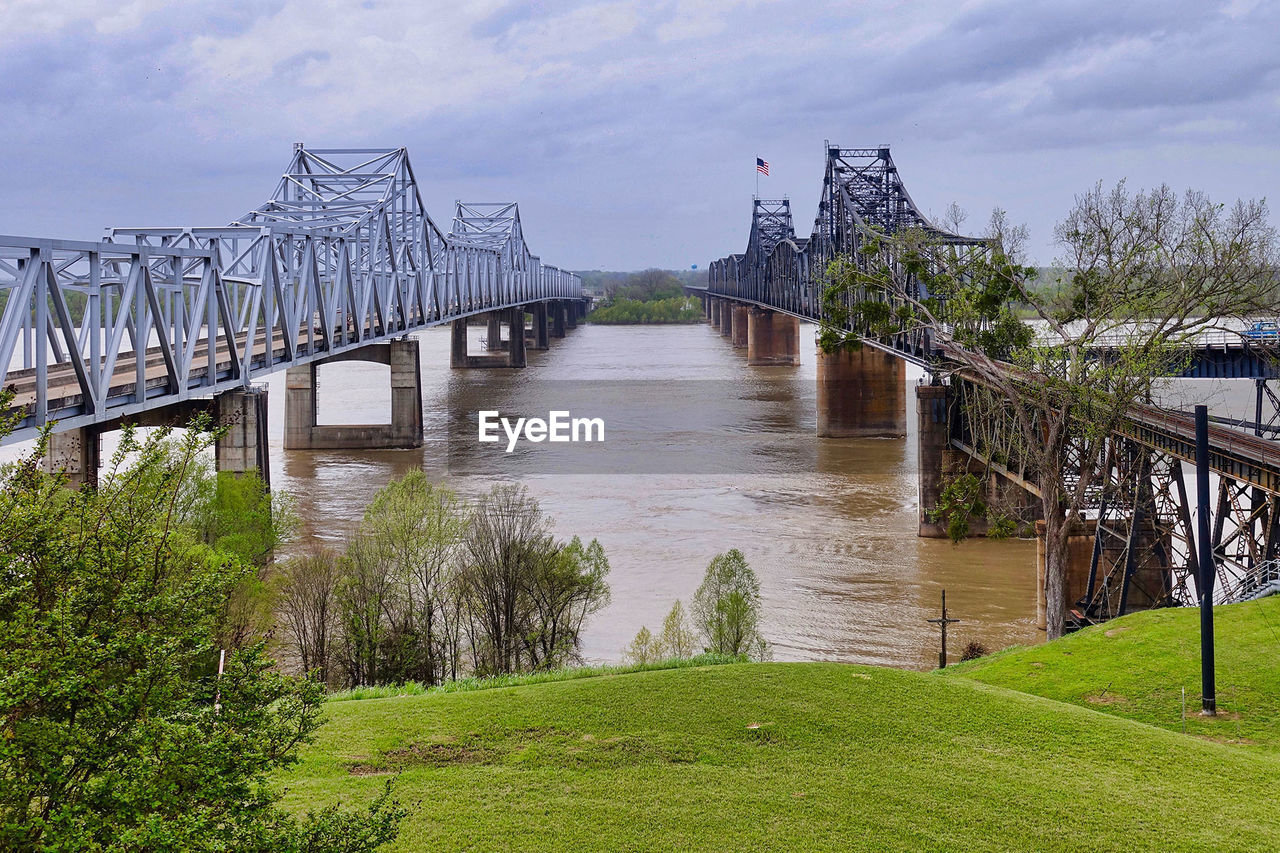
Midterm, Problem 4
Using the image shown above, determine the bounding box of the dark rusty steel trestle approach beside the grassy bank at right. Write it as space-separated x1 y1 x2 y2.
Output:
948 375 1280 604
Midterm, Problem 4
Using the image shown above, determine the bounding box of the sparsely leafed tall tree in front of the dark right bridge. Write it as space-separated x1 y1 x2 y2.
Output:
819 182 1277 638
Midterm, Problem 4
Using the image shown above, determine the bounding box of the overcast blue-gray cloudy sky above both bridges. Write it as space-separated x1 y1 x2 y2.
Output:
0 0 1280 269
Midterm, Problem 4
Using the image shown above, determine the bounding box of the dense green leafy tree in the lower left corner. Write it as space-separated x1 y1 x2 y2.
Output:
0 424 403 850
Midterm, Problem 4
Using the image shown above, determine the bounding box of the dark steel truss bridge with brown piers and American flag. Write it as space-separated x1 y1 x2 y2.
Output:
689 143 1280 624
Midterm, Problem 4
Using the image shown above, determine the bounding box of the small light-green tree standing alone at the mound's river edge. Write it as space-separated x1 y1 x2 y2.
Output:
692 548 769 660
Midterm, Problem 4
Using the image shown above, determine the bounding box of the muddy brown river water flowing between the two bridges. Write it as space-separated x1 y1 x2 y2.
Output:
269 325 1039 667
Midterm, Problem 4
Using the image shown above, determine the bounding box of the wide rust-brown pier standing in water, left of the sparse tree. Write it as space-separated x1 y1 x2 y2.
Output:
818 346 906 438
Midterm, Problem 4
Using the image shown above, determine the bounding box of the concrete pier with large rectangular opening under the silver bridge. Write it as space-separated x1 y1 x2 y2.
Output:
284 328 422 450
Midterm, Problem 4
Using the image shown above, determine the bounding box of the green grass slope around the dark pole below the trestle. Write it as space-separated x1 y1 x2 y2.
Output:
946 596 1280 751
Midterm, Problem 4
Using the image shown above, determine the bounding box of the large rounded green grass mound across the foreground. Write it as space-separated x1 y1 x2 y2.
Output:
284 663 1280 850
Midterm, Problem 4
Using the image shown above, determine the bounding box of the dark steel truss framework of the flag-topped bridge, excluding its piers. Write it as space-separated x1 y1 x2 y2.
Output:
705 143 1280 607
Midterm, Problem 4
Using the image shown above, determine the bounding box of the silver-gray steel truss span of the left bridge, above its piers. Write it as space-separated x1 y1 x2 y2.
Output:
0 145 581 443
